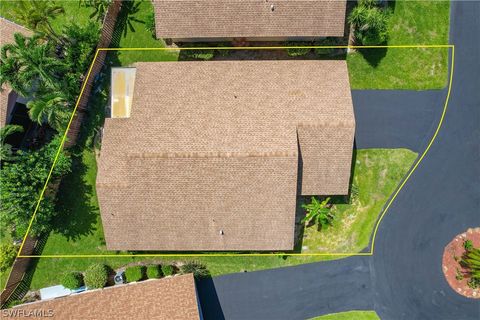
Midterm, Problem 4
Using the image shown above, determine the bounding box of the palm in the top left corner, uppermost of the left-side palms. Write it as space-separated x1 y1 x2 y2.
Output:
13 0 65 42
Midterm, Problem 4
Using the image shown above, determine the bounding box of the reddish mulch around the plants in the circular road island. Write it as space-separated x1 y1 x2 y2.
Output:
442 228 480 299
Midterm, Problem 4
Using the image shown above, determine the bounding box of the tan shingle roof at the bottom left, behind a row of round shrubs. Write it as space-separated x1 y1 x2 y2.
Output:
2 274 200 320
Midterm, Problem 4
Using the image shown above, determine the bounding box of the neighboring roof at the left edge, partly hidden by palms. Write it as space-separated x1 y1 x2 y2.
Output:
0 17 32 127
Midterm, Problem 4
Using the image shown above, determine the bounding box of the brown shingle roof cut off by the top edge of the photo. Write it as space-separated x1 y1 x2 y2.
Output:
153 0 346 38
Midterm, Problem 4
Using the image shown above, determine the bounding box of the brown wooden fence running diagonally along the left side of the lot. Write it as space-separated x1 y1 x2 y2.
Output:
0 0 122 308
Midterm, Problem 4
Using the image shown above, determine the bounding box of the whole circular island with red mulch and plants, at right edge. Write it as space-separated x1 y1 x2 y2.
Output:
442 228 480 299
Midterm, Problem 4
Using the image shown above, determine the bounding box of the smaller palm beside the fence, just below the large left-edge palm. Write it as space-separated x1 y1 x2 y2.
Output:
27 91 71 132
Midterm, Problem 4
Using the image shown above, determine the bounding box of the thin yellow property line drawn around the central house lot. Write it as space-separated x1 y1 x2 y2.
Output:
17 44 455 258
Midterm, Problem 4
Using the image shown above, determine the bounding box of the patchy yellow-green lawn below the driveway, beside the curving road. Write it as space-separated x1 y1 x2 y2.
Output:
302 149 417 253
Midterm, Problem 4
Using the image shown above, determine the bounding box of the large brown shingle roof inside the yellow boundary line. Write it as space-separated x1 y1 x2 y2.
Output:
97 60 355 250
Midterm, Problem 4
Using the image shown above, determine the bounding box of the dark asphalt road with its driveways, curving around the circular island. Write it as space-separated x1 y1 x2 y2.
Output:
198 1 480 320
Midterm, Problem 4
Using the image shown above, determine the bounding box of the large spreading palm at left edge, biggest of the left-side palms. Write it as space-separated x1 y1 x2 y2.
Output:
0 33 65 96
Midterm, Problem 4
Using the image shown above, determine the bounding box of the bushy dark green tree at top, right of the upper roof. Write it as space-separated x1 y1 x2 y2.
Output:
348 1 389 45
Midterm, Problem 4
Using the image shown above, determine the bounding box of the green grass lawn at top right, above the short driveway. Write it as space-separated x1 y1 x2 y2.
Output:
347 0 450 90
